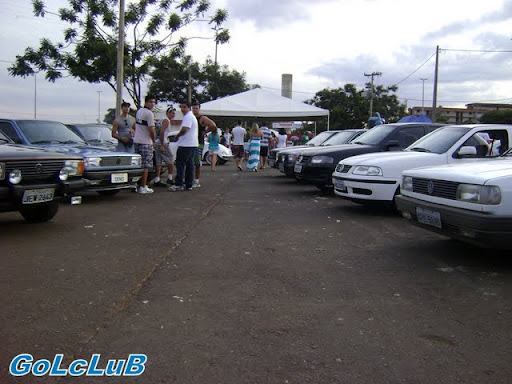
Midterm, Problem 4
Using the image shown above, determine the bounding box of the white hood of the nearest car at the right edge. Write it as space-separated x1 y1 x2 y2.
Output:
404 158 512 184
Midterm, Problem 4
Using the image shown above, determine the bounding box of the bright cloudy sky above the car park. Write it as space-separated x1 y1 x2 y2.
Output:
0 0 512 122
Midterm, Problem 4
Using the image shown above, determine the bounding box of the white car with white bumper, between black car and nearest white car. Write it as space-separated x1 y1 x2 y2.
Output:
332 124 512 204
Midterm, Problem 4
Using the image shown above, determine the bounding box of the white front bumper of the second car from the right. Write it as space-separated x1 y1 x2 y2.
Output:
332 172 400 202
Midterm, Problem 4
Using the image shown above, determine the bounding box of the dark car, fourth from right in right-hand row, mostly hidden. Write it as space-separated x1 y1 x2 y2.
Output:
277 129 367 177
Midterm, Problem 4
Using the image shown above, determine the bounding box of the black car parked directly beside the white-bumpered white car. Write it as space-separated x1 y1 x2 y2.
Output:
294 123 443 191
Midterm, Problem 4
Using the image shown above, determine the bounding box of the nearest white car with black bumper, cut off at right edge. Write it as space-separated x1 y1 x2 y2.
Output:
396 151 512 249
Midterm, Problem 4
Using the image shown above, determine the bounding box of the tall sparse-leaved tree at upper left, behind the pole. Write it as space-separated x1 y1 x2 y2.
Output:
8 0 229 107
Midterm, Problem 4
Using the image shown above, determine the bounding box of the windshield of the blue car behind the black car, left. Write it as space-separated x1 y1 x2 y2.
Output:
18 120 85 144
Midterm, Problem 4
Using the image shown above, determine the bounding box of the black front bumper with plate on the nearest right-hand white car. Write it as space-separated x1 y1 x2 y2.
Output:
396 195 512 249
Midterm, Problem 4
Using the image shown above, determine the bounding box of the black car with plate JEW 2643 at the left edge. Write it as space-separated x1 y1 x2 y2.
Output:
0 132 85 223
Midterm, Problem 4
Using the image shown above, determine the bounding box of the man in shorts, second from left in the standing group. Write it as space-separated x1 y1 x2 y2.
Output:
133 95 156 194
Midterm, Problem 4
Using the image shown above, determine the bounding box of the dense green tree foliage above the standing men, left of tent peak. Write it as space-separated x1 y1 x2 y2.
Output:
149 56 254 103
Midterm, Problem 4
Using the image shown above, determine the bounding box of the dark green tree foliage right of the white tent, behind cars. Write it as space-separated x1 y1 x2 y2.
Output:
306 84 406 130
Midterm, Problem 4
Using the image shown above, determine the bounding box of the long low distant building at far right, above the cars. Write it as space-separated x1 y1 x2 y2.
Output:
409 103 512 124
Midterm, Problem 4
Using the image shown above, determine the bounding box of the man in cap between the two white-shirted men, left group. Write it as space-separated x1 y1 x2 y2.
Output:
153 107 176 187
